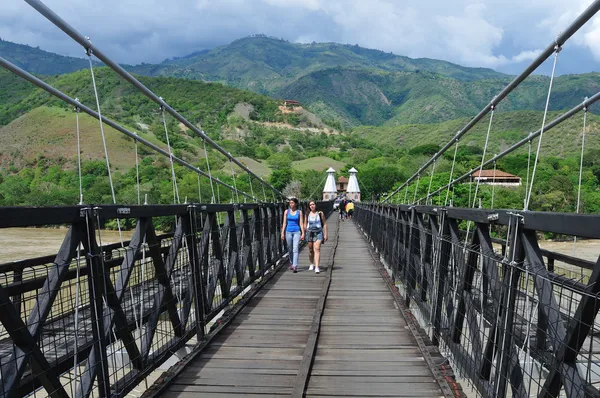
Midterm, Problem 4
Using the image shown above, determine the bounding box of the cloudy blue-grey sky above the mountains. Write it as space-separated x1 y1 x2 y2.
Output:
0 0 600 74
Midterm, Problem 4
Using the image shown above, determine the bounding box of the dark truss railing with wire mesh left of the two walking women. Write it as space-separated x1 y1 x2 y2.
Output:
0 202 332 398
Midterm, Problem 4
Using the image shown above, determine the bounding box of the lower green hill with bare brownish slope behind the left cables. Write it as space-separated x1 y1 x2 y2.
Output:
0 67 349 174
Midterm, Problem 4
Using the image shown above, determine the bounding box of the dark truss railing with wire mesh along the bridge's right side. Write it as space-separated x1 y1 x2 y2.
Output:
354 204 600 397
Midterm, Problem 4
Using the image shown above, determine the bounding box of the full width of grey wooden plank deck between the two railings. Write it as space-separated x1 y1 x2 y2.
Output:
155 217 443 397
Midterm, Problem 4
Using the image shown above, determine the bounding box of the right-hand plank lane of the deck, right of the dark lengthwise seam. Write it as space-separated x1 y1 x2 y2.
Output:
306 221 443 397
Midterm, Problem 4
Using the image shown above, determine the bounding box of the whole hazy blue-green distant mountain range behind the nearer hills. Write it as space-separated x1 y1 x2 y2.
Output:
0 35 600 128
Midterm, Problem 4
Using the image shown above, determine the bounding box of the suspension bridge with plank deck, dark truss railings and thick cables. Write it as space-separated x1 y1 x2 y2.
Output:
0 0 600 397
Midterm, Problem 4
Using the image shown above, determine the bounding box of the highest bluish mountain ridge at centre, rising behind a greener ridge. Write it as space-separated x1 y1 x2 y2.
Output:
131 35 506 94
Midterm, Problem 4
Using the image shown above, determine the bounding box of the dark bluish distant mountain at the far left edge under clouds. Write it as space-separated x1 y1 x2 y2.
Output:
0 39 98 75
